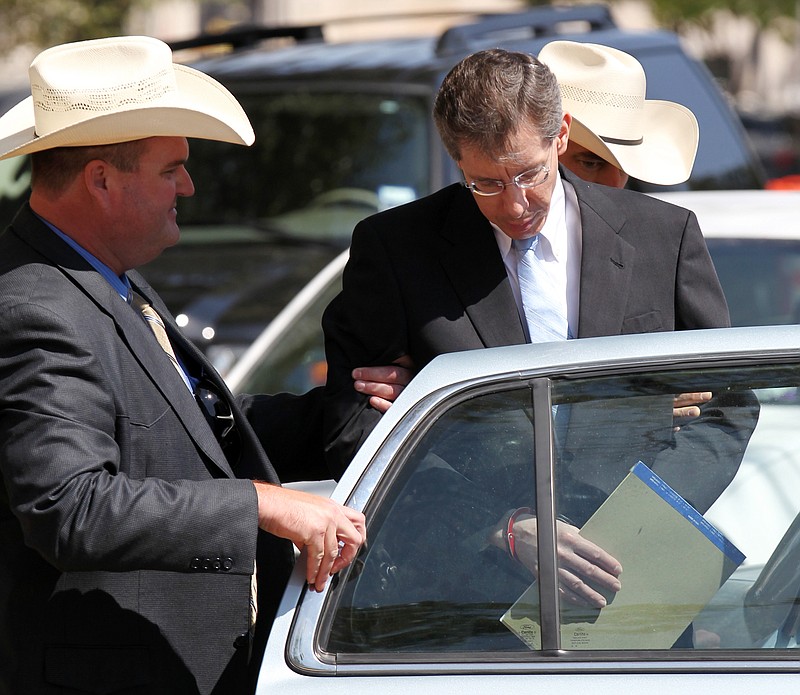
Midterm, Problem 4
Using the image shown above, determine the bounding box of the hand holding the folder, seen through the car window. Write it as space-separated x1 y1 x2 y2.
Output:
504 514 622 608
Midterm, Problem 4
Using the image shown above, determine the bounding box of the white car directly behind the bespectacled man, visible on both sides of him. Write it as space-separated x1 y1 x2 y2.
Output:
227 190 800 400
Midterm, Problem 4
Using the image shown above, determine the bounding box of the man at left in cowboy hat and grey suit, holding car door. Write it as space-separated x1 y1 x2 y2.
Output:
0 37 406 695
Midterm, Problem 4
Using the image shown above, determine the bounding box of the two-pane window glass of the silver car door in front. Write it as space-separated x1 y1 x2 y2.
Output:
322 366 800 660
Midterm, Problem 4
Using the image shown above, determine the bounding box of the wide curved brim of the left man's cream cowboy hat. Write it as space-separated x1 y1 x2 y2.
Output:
0 65 255 159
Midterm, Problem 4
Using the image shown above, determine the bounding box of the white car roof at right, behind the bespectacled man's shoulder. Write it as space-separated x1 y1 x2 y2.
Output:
650 189 800 240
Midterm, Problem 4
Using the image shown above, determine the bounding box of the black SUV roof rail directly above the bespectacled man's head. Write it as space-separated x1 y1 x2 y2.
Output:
436 4 617 56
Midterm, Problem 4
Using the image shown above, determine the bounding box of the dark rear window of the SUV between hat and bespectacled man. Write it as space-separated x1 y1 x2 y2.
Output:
181 92 430 237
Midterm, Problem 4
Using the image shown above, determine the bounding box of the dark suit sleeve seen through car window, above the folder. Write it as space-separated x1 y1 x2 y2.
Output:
558 384 759 526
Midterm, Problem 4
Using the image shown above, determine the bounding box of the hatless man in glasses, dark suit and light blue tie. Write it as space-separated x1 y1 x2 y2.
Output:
322 49 757 624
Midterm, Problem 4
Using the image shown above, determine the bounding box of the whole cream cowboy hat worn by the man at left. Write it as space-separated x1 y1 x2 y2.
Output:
0 36 255 159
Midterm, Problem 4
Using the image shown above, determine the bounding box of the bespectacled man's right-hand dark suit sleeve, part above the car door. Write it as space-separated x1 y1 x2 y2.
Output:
675 212 730 331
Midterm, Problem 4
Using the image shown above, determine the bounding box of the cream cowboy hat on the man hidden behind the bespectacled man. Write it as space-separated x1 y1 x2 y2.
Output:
539 41 700 185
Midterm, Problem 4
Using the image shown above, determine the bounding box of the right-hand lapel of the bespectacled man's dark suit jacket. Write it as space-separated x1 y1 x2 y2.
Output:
562 169 636 338
